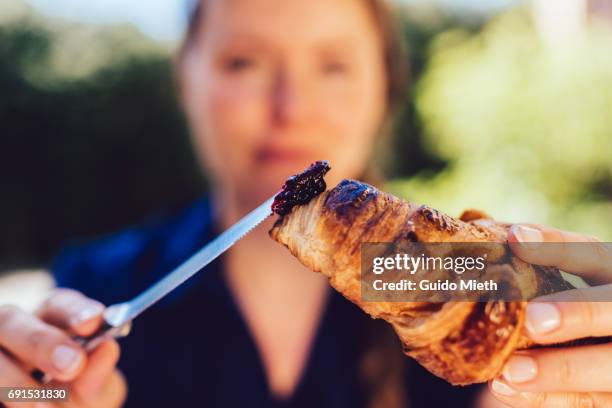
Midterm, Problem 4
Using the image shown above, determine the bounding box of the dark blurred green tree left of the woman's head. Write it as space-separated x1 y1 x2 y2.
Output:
0 15 205 268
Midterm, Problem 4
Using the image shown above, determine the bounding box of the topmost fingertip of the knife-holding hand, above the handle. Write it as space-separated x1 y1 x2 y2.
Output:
37 289 104 336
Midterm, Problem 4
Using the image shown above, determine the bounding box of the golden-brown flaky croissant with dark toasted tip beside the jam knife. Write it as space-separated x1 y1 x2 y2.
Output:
270 180 570 385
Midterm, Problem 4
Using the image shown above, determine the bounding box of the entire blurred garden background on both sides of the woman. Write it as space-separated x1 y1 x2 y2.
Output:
0 0 612 306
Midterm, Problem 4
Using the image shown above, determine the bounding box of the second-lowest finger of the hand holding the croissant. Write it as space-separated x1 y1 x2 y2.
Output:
502 344 612 392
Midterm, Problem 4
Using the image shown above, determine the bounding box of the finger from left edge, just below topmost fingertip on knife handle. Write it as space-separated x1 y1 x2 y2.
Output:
0 306 87 381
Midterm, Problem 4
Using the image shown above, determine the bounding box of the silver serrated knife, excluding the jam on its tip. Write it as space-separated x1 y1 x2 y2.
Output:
33 194 276 383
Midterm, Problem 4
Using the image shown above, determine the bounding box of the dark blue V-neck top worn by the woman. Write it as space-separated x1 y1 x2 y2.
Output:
52 199 477 408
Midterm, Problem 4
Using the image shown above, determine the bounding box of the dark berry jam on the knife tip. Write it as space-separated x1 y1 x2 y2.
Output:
272 160 331 216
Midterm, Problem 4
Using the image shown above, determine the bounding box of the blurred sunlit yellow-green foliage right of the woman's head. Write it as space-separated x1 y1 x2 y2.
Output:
392 10 612 239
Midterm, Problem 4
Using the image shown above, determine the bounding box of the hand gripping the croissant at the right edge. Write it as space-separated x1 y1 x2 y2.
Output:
489 225 612 408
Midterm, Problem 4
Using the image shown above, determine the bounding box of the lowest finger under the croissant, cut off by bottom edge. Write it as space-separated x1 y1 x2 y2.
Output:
489 379 612 408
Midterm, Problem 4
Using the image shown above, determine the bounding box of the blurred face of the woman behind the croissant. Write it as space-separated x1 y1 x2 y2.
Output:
182 0 386 205
